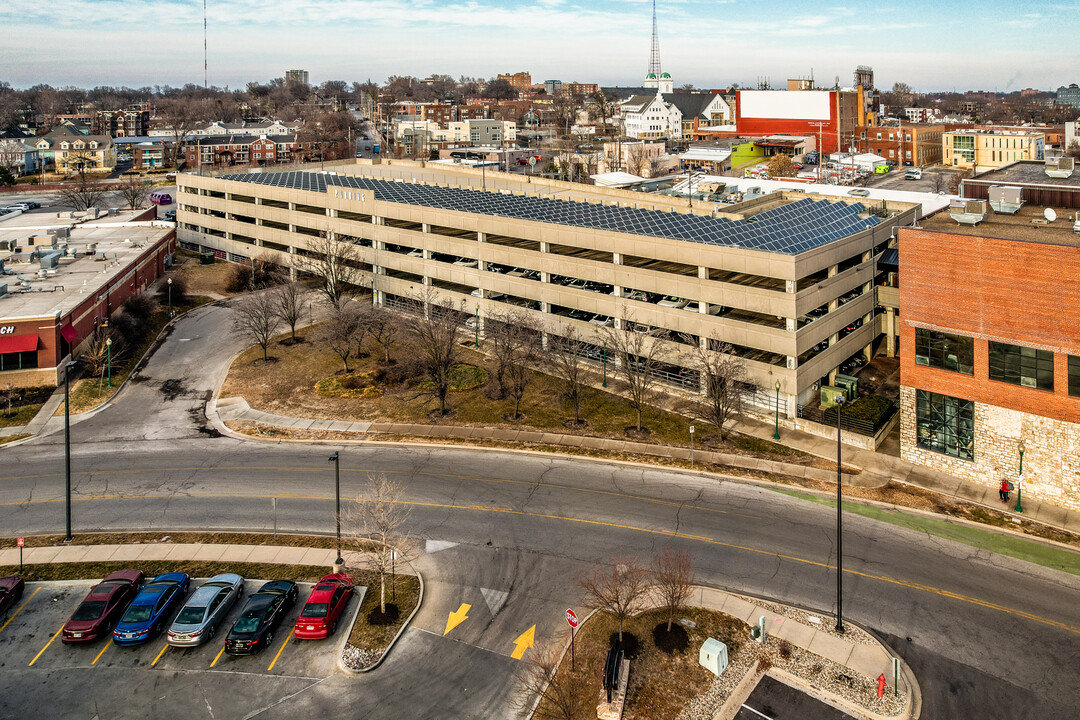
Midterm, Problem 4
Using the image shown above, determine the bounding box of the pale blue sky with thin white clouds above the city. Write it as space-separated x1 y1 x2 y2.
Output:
0 0 1080 92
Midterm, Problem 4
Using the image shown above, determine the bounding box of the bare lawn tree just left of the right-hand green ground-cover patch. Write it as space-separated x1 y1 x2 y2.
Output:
409 288 464 416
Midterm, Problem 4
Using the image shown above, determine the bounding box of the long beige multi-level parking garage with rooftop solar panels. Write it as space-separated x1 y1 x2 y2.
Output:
177 161 917 417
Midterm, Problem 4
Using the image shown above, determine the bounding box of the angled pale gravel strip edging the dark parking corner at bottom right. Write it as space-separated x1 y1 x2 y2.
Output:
678 637 905 720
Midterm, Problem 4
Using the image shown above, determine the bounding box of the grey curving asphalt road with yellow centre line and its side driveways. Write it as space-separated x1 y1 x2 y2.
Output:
0 307 1080 718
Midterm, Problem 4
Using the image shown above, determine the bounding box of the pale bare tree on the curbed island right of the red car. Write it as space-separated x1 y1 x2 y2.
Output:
341 475 417 615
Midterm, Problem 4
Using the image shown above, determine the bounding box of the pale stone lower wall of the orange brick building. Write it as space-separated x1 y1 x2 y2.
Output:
900 386 1080 511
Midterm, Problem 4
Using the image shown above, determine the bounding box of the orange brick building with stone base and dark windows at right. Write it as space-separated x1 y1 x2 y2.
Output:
899 204 1080 511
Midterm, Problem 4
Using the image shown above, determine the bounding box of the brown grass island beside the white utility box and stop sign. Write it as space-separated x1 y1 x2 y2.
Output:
537 608 750 720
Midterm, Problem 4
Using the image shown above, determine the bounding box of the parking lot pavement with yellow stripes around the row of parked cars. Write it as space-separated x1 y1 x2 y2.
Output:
0 579 363 693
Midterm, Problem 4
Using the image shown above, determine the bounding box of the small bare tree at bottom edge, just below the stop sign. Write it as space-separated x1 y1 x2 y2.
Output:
514 643 591 720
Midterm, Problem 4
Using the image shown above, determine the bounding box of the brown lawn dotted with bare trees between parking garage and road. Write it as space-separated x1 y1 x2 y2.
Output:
221 315 814 464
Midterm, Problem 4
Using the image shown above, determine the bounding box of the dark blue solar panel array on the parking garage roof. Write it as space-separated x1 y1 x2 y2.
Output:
214 173 880 255
